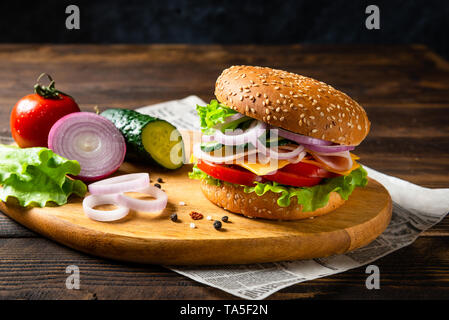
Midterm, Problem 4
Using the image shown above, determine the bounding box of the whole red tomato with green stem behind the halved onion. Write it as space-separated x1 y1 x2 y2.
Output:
10 75 81 148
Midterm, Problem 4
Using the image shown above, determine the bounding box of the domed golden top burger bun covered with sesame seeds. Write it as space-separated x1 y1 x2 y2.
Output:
215 66 370 145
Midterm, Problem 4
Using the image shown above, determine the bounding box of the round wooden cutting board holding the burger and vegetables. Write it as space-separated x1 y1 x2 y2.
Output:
0 163 392 265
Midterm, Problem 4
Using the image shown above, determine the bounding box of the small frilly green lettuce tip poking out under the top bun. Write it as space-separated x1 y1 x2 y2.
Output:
196 100 238 134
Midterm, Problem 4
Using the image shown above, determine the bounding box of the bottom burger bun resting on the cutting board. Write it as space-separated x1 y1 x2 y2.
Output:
201 180 345 220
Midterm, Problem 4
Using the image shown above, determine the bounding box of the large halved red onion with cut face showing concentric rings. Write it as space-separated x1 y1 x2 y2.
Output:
48 112 126 181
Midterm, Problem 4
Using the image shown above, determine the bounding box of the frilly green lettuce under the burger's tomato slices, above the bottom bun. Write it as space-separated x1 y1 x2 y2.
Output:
189 165 368 212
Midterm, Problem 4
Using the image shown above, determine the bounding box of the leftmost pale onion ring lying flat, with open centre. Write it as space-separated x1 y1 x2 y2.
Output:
83 195 129 222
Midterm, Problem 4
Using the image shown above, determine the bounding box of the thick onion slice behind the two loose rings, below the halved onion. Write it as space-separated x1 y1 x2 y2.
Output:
89 173 150 194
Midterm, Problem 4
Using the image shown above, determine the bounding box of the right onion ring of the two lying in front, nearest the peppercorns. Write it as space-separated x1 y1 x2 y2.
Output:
115 186 168 212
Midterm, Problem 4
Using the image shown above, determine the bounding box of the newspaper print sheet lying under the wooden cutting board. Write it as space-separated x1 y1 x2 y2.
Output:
138 96 449 300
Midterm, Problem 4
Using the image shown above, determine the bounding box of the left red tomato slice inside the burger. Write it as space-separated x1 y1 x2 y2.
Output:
196 159 262 186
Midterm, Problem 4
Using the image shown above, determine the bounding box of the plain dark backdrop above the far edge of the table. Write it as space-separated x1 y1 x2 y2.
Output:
0 0 449 58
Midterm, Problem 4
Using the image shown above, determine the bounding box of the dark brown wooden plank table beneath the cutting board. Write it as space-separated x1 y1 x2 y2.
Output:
0 45 449 299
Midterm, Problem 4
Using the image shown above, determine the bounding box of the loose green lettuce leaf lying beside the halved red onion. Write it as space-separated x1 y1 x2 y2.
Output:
0 144 87 207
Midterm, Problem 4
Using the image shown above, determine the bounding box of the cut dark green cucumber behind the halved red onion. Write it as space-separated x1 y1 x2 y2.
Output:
100 109 184 169
